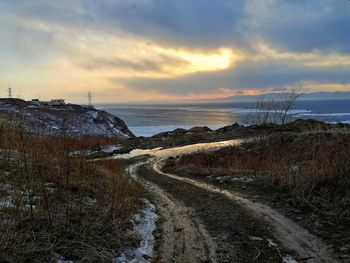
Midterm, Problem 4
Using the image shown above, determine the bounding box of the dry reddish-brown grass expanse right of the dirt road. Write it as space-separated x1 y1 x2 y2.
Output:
177 133 350 220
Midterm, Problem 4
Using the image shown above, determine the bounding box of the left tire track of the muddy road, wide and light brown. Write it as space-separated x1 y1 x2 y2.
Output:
127 160 216 263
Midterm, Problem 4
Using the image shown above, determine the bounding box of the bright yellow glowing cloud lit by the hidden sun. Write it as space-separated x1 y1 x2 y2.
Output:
65 35 243 79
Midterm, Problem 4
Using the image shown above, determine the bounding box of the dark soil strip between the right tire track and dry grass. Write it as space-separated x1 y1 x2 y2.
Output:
164 160 350 263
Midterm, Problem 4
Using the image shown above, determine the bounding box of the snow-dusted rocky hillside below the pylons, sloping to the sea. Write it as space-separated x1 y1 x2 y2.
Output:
0 99 134 139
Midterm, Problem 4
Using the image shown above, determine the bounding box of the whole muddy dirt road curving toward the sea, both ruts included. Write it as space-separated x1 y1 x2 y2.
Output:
116 140 338 263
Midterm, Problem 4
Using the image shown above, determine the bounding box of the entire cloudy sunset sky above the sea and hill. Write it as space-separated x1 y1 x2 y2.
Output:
0 0 350 103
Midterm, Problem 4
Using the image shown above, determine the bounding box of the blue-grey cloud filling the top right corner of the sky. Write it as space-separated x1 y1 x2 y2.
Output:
241 0 350 53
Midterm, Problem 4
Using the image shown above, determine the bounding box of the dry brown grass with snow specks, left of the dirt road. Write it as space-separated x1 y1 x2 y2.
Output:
0 123 142 263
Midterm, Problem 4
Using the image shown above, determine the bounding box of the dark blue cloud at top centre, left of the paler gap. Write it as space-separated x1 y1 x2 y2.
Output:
84 0 245 47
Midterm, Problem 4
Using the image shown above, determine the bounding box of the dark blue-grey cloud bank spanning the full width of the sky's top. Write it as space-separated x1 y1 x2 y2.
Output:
0 0 350 52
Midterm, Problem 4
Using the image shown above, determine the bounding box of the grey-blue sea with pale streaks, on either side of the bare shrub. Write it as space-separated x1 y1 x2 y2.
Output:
96 99 350 137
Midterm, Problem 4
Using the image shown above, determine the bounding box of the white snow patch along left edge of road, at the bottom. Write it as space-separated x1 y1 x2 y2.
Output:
115 200 158 263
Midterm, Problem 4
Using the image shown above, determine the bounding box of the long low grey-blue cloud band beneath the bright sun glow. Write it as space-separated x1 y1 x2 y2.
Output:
116 57 350 95
